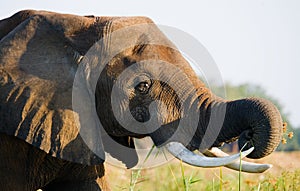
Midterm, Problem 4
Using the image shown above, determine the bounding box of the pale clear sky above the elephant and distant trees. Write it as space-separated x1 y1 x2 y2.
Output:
0 0 300 127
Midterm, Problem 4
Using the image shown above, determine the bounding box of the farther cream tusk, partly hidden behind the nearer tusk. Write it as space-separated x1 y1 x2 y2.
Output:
204 147 272 173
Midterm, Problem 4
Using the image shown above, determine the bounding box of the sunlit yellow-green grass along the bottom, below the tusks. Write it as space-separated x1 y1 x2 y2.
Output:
108 162 300 191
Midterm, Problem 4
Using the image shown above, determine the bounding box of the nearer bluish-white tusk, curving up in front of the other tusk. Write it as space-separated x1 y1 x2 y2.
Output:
165 142 254 168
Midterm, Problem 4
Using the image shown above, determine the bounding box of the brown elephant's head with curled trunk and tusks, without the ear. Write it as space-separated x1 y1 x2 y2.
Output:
90 14 282 172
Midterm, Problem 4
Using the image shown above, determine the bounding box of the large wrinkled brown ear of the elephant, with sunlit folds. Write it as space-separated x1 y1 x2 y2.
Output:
0 11 104 165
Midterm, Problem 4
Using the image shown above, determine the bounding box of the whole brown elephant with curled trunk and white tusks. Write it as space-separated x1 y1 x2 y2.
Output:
0 10 283 191
